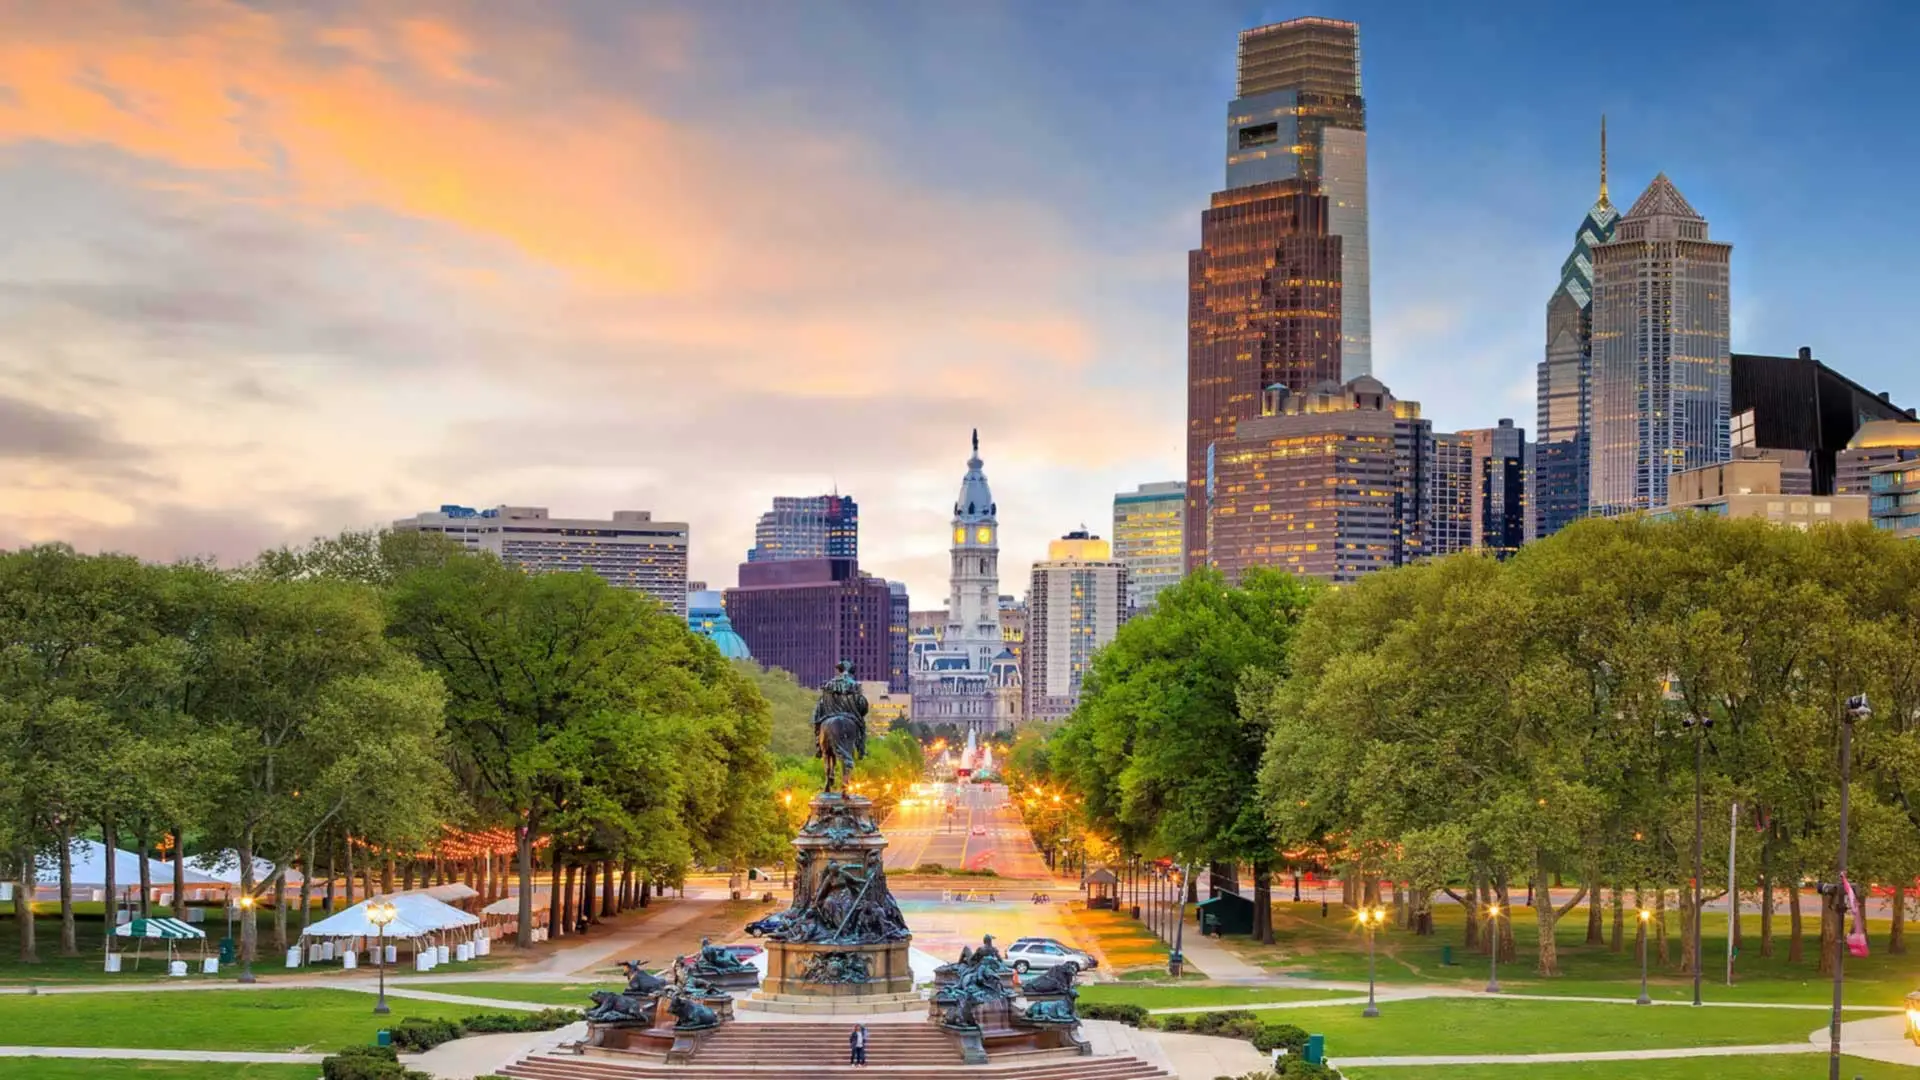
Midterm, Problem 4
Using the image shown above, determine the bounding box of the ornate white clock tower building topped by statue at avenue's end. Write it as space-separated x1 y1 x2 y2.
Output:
908 430 1020 736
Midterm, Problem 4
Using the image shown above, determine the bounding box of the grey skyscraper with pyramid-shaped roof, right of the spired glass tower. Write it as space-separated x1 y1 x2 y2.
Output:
1586 173 1734 515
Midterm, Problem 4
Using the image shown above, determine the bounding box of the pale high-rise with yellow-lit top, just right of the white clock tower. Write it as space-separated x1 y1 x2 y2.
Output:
1027 528 1127 721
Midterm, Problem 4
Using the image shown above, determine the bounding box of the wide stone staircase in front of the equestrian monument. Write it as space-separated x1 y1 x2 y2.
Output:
503 1024 1167 1080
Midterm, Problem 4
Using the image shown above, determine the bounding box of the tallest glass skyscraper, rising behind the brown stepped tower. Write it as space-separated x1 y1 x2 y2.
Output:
1227 19 1373 380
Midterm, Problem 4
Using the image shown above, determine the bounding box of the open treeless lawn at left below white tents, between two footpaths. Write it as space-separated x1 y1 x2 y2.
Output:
0 990 472 1053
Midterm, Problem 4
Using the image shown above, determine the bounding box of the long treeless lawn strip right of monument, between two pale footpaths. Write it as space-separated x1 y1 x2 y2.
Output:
1261 997 1864 1061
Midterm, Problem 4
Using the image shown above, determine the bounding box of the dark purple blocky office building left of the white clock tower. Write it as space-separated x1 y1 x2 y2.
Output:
726 559 893 686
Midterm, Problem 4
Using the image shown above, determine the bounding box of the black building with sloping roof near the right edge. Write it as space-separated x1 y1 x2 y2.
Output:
1730 346 1914 496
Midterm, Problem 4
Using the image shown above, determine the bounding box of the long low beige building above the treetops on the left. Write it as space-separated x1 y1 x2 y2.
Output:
394 505 687 619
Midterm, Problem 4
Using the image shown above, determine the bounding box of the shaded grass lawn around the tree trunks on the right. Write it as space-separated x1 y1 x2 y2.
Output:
1223 903 1920 1007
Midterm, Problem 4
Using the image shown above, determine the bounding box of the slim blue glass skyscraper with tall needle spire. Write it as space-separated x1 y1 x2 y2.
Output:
1532 117 1620 536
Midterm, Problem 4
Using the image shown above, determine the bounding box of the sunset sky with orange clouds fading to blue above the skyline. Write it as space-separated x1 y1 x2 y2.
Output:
0 0 1920 607
